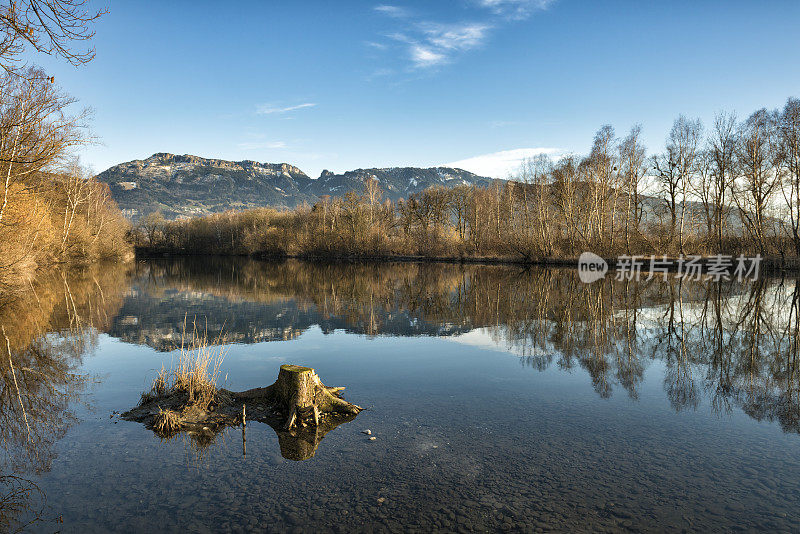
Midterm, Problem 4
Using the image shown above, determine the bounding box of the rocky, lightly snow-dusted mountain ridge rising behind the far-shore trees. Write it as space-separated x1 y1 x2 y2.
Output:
97 152 492 220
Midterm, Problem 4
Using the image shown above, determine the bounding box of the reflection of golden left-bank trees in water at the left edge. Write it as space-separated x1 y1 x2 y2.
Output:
0 265 126 532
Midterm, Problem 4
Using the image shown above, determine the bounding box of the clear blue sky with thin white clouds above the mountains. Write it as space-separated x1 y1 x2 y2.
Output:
28 0 800 177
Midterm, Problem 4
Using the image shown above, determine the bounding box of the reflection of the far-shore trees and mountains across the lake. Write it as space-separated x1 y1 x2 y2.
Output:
110 258 800 438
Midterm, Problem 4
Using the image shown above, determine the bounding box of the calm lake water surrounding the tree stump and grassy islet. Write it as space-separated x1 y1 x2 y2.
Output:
0 258 800 532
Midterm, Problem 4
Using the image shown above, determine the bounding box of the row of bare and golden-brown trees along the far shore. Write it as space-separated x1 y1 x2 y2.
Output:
138 98 800 261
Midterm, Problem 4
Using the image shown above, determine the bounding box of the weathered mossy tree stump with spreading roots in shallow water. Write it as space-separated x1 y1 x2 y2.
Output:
236 364 361 430
